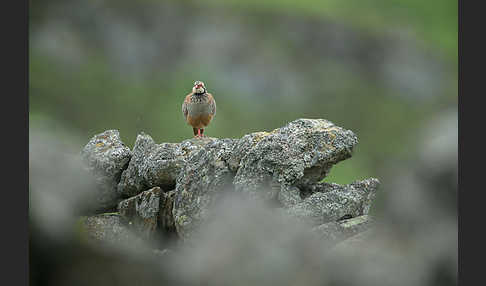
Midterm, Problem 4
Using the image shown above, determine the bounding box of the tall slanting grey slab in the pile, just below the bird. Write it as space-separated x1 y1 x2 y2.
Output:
172 139 235 239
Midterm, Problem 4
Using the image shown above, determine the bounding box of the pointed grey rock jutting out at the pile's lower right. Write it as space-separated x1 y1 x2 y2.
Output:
285 178 379 225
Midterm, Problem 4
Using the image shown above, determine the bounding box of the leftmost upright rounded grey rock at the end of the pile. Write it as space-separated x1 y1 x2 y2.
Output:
81 130 131 211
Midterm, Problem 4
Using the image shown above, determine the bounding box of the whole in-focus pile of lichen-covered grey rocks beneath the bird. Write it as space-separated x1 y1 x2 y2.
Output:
82 119 379 242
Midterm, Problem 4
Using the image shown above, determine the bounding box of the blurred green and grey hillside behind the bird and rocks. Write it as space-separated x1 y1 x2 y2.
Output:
29 0 458 189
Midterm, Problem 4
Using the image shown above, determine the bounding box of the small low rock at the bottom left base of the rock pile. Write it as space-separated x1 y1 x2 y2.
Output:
81 213 132 243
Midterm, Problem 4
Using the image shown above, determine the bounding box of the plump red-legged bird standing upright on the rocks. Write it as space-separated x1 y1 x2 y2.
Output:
182 80 216 138
